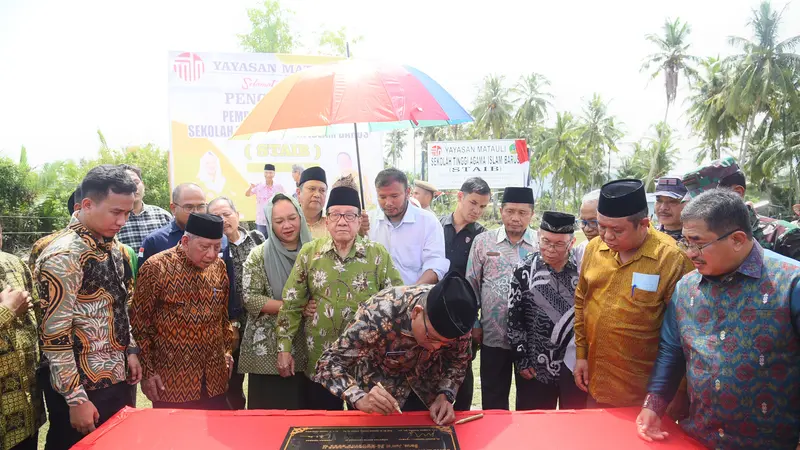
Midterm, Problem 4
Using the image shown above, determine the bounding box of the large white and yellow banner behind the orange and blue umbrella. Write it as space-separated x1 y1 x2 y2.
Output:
168 52 383 220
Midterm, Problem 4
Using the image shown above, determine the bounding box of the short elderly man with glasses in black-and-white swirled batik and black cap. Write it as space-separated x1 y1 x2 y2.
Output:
508 211 586 411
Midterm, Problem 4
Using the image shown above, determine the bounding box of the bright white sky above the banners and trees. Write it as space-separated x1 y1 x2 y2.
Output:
0 0 800 173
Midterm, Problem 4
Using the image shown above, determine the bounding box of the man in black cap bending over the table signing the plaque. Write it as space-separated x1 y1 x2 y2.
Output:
314 272 477 425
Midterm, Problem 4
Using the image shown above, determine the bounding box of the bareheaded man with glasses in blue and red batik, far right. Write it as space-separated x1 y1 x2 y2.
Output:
637 189 800 450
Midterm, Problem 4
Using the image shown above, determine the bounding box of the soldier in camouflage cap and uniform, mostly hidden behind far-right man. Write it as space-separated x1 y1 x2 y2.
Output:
683 156 800 260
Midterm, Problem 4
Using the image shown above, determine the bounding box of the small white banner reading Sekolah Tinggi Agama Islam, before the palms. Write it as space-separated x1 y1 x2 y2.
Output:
428 139 530 190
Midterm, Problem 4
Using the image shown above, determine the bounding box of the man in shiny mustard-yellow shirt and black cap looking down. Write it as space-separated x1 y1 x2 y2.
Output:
574 180 693 408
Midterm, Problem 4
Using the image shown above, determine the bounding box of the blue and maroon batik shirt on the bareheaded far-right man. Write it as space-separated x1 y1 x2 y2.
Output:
645 244 800 450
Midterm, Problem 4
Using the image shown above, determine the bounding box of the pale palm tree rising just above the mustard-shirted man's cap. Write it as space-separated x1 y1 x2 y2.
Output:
580 93 623 185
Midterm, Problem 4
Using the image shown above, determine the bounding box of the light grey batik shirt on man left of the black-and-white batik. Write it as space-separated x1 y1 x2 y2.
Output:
467 227 539 350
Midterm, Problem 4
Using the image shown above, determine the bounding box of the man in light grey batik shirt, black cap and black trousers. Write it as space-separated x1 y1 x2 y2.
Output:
466 187 538 410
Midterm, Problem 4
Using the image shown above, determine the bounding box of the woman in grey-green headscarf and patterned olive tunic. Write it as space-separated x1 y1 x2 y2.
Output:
239 193 312 409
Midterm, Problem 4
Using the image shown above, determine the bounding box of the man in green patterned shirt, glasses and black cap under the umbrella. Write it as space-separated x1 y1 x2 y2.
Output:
275 186 403 410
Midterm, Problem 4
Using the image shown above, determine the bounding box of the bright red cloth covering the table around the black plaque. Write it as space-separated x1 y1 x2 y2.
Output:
73 408 703 450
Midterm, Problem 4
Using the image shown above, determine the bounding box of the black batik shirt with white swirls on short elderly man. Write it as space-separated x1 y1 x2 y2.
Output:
508 251 578 384
